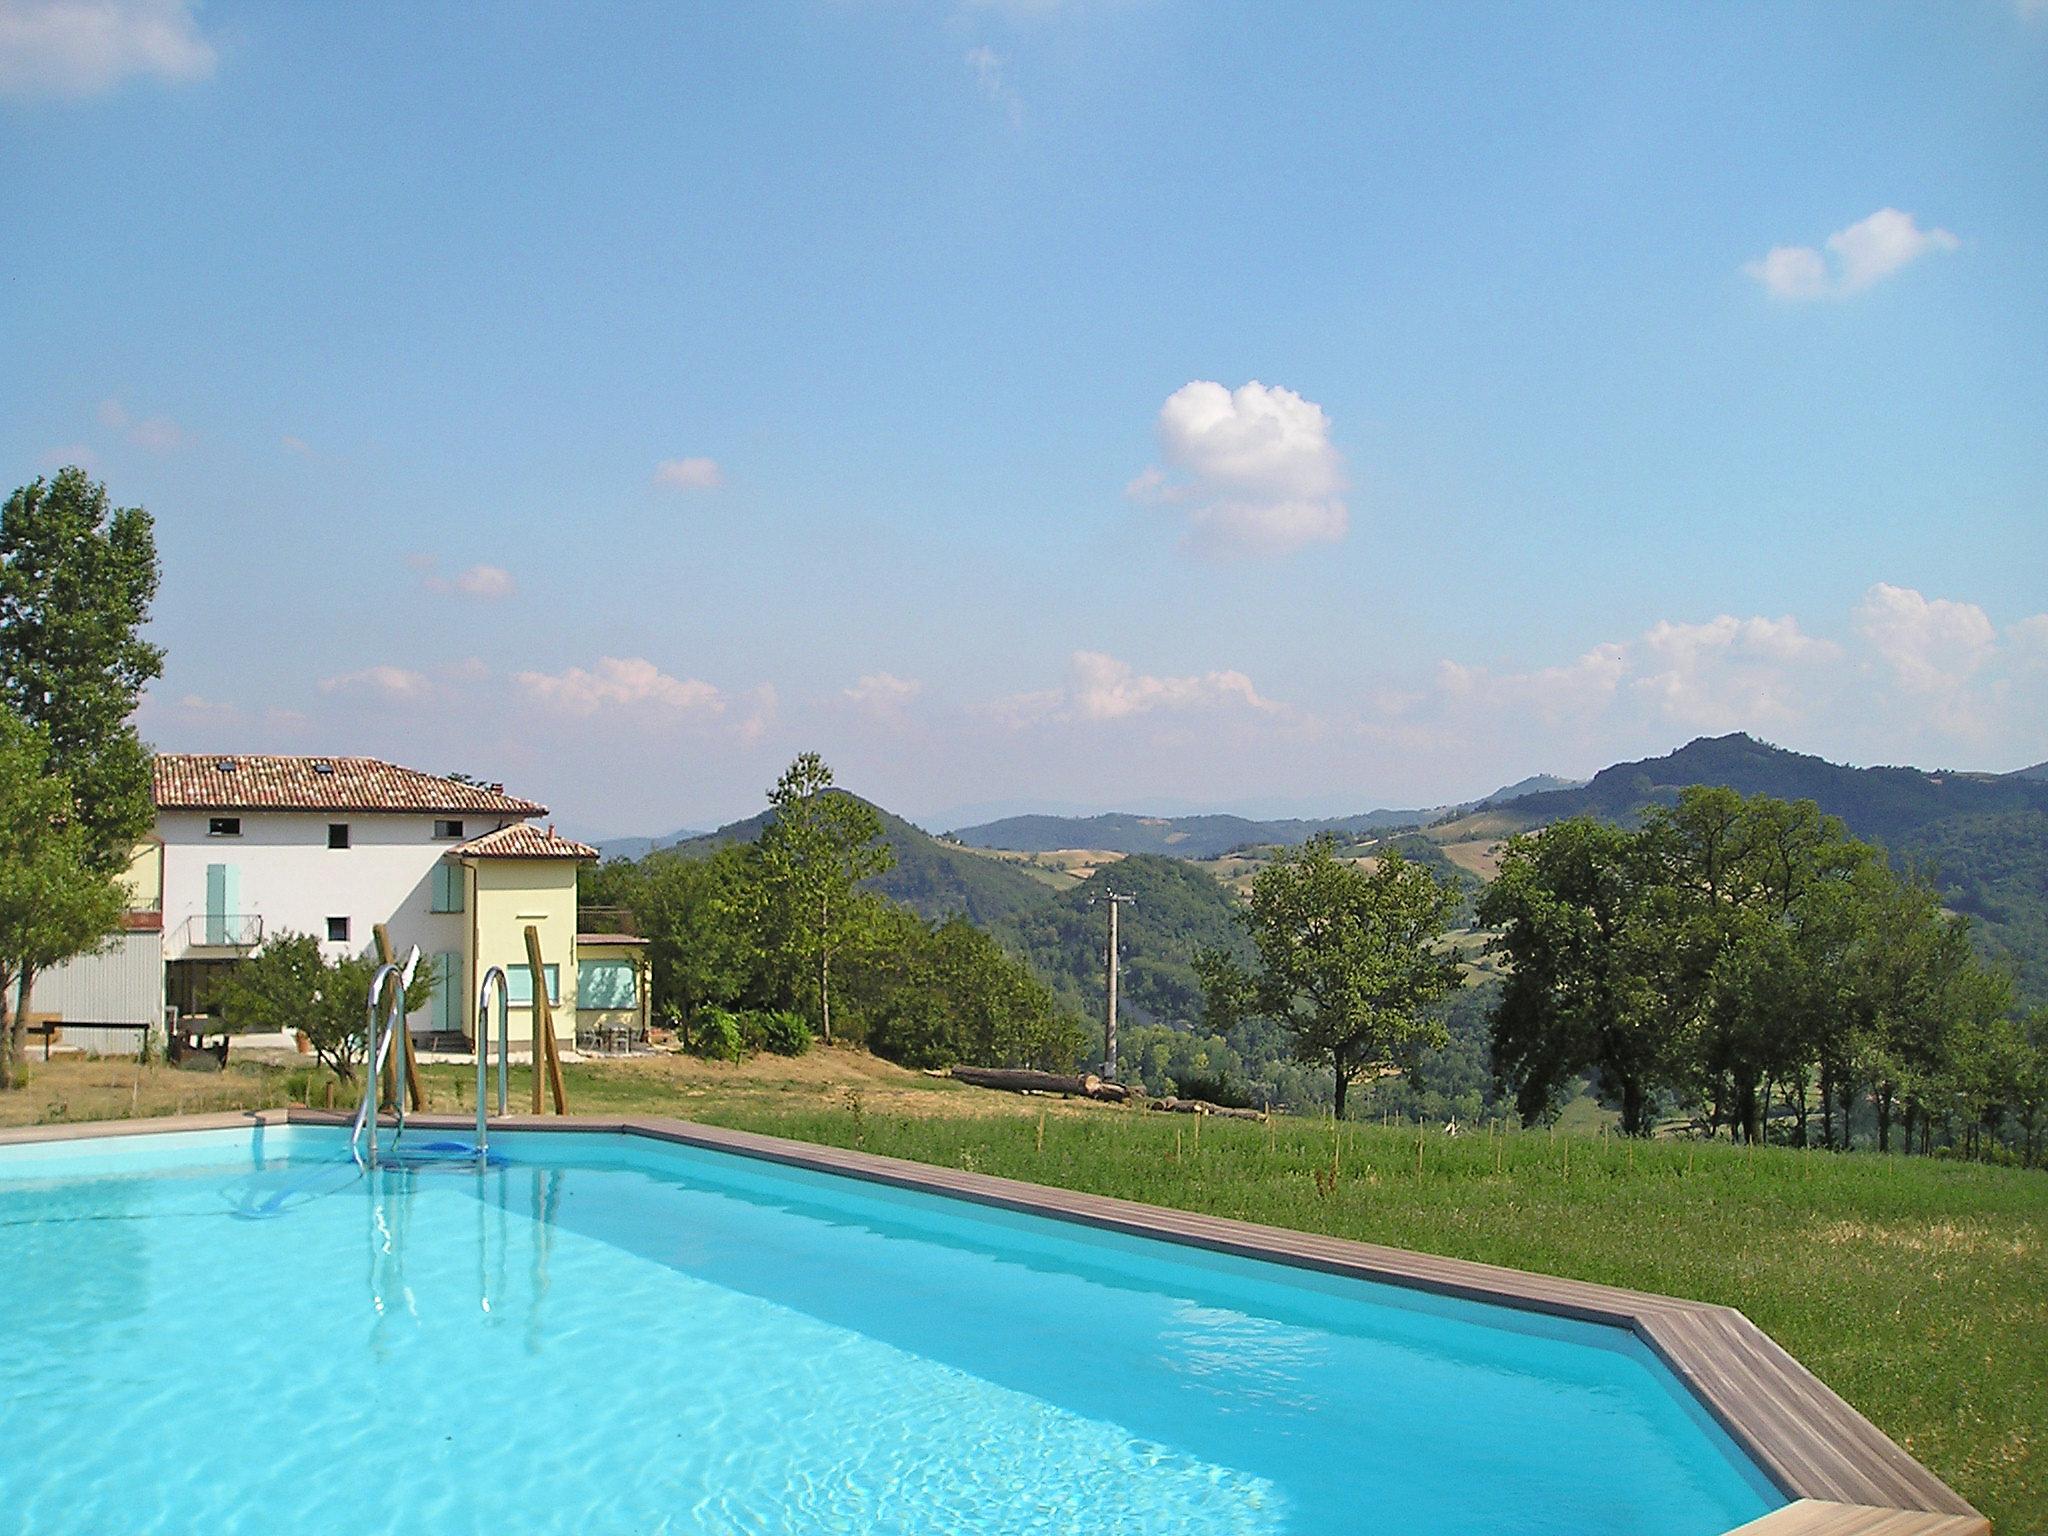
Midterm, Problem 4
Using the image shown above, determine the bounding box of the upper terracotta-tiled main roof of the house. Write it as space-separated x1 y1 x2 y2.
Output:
154 752 547 815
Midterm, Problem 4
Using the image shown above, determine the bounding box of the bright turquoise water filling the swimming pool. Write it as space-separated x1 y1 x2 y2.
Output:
0 1126 1784 1536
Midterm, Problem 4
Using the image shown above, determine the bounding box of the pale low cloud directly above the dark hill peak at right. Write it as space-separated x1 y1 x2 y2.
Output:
1630 614 1841 731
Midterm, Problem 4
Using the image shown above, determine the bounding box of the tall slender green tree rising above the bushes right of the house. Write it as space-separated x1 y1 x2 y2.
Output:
760 752 895 1042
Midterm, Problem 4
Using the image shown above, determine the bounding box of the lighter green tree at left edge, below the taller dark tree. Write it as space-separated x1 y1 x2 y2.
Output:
0 702 123 1087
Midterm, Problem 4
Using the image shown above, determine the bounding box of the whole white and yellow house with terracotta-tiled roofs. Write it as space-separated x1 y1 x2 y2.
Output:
31 754 645 1047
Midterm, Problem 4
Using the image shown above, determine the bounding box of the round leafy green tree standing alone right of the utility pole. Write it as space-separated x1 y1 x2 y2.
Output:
1202 834 1460 1120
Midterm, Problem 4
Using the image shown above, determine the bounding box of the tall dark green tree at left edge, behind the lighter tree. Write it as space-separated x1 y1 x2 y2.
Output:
0 467 164 1073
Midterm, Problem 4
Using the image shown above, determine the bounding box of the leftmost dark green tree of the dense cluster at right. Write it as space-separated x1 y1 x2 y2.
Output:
1479 817 1673 1137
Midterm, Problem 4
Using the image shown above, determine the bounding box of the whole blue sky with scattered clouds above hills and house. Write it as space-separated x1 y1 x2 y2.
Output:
0 0 2048 834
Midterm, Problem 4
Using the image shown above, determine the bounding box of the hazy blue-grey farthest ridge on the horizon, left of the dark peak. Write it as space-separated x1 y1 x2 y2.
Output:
946 774 1577 858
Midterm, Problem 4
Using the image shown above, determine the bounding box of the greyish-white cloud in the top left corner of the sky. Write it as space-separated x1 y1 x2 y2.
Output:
0 0 215 96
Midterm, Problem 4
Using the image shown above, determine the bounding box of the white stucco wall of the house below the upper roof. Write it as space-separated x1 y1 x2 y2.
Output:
156 811 508 1003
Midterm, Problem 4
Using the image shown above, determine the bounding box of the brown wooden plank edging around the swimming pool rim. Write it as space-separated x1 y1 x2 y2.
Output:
0 1108 1991 1536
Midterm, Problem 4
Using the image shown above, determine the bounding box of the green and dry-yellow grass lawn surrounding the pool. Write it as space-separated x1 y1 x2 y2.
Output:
0 1051 2048 1536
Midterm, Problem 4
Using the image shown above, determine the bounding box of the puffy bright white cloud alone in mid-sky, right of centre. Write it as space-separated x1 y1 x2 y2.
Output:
1124 379 1350 555
